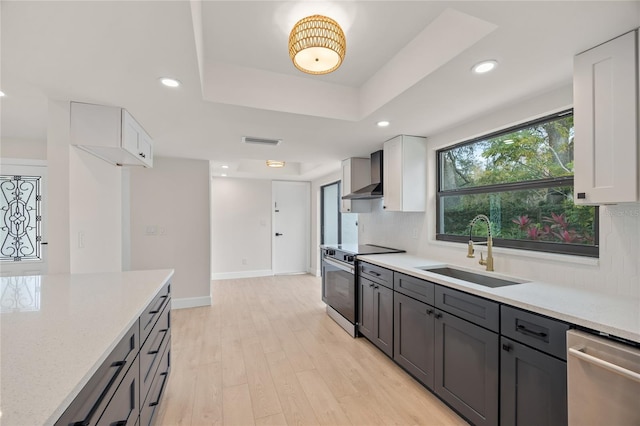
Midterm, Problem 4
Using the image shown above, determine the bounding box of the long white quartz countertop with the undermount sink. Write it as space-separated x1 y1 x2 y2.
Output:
358 254 640 342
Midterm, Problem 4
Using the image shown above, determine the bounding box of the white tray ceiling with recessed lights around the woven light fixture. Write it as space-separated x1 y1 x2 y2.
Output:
0 0 640 179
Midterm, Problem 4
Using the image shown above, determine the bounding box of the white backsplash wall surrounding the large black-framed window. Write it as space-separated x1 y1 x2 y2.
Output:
360 86 640 296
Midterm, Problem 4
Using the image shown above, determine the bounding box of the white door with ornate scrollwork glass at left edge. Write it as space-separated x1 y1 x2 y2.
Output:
0 161 48 276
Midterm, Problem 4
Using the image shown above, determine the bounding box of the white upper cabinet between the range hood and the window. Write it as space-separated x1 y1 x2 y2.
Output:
382 135 427 212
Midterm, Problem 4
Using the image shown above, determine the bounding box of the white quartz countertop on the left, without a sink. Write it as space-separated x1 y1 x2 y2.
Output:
0 269 173 426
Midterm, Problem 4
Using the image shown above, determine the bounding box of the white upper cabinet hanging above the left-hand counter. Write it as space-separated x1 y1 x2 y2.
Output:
71 102 153 167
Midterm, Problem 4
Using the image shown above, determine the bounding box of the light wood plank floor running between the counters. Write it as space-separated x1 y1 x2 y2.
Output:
156 275 466 426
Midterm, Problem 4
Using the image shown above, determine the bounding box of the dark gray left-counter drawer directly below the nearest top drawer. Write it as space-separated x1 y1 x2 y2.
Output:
97 358 140 426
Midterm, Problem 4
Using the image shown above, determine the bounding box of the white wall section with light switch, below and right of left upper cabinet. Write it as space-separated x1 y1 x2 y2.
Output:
129 157 211 308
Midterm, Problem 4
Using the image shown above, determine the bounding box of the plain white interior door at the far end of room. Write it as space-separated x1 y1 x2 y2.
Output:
271 181 311 275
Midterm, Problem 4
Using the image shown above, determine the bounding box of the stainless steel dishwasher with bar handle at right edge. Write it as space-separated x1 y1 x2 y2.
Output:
567 330 640 426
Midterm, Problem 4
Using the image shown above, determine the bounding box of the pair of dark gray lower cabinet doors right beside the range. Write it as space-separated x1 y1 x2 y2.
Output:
358 276 393 357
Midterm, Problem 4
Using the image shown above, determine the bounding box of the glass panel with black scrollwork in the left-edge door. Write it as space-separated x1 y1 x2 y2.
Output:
0 175 42 262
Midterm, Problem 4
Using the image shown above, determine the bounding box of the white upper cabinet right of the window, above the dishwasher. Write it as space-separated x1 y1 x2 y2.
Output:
573 31 640 205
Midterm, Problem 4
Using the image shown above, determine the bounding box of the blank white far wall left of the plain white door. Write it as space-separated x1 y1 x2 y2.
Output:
211 177 272 279
